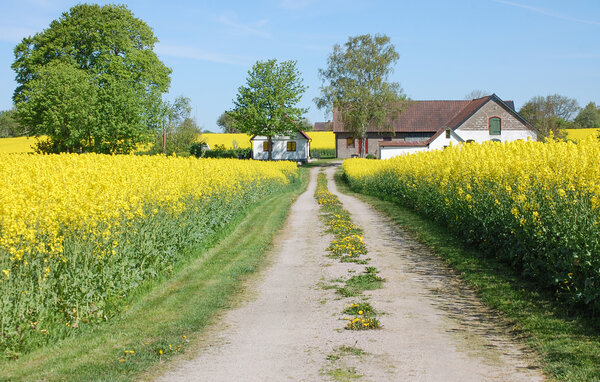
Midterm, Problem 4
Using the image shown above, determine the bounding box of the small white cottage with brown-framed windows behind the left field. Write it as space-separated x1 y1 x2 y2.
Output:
250 131 310 162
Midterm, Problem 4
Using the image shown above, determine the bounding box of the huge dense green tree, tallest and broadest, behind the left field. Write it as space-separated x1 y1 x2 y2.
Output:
12 4 171 153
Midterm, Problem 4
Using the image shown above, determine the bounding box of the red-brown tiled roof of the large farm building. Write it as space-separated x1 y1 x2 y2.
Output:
333 94 522 133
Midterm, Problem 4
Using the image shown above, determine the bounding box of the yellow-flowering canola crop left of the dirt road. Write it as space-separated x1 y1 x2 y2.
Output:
0 154 297 354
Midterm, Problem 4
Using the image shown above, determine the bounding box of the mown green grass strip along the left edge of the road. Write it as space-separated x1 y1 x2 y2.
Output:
0 170 308 381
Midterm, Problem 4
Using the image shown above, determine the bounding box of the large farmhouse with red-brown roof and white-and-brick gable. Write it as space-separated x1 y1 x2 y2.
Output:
333 94 537 159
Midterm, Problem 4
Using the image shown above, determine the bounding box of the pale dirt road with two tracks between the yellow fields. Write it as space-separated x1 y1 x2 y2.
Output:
158 168 544 382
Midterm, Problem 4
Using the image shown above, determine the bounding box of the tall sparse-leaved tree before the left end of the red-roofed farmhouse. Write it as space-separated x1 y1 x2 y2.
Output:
315 35 406 155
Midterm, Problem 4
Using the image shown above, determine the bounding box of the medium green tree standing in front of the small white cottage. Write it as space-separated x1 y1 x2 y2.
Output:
228 59 307 160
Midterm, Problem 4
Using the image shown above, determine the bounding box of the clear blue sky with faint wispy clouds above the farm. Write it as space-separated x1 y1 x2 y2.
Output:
0 0 600 131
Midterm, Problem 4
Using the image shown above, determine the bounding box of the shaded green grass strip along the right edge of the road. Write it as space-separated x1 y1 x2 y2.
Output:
335 172 600 382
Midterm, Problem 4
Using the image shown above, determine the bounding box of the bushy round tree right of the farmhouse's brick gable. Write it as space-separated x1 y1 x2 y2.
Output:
519 94 579 139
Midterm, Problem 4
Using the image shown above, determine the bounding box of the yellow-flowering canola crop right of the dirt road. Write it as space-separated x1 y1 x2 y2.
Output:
343 139 600 314
